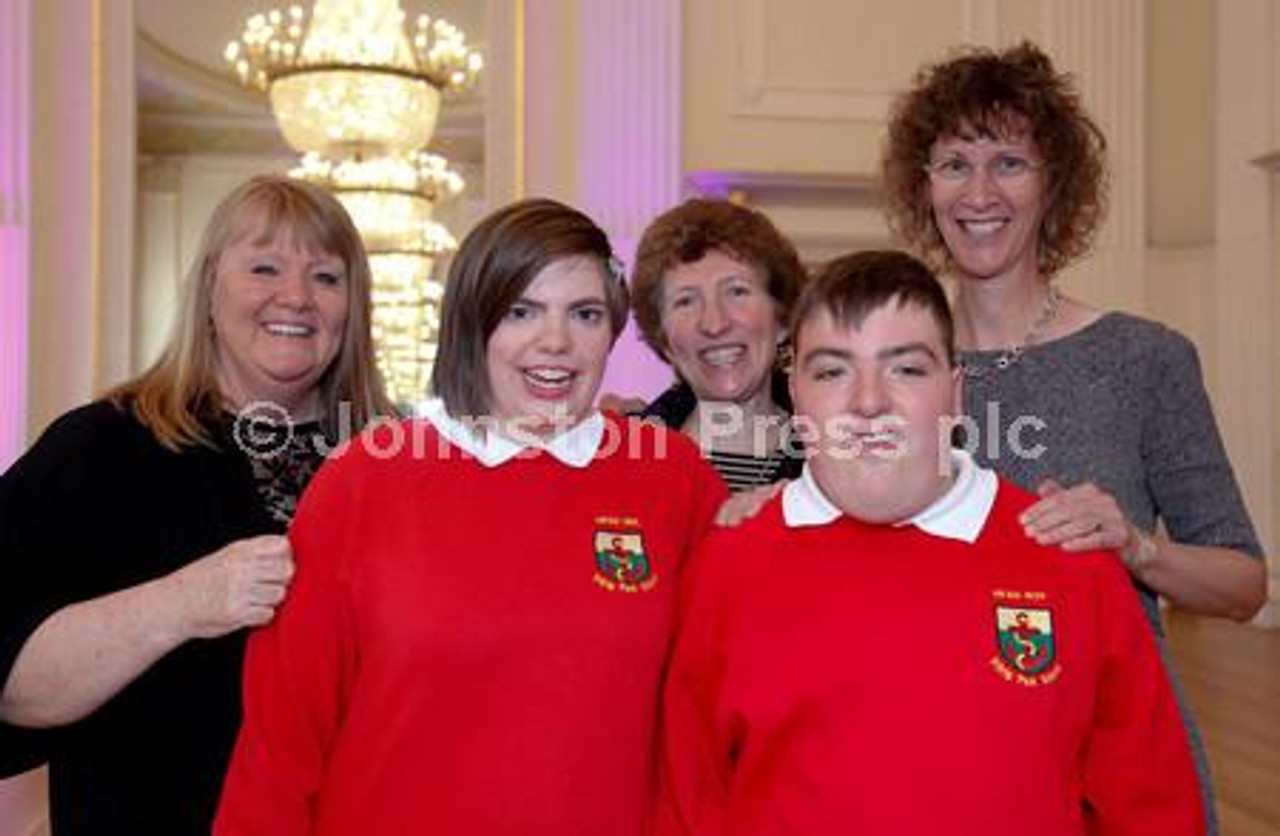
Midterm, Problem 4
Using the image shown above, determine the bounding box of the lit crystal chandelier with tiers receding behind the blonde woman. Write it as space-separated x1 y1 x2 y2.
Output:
227 0 481 405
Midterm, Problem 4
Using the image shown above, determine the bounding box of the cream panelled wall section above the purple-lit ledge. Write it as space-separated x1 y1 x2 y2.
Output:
685 0 997 177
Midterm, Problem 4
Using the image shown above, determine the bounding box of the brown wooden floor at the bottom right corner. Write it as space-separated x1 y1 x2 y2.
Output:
1169 611 1280 836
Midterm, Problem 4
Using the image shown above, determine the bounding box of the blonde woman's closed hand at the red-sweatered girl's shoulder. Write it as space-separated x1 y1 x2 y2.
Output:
165 534 293 639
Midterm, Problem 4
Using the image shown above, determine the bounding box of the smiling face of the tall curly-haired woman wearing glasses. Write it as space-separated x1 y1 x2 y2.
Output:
928 131 1048 279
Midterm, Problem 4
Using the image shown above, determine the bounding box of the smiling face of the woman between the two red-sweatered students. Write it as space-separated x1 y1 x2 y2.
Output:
662 250 782 403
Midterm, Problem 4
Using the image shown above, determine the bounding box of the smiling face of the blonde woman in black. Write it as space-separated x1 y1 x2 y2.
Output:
210 229 349 416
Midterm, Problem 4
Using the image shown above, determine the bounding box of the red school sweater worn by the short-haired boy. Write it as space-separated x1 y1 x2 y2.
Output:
657 483 1203 836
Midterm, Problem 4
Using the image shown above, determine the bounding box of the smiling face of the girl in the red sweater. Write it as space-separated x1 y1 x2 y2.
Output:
485 256 613 435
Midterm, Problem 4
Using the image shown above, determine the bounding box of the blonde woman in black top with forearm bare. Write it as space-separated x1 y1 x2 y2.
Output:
0 177 390 836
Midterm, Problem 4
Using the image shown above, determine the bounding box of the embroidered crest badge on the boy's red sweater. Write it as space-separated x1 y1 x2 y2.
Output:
991 589 1062 686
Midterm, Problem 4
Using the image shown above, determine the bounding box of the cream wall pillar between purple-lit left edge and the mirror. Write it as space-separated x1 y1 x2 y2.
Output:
26 0 137 440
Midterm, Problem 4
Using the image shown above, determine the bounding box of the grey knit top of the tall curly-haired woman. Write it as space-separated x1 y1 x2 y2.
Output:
961 314 1262 624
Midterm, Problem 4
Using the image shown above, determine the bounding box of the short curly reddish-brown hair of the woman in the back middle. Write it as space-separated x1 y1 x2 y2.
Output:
631 197 805 358
